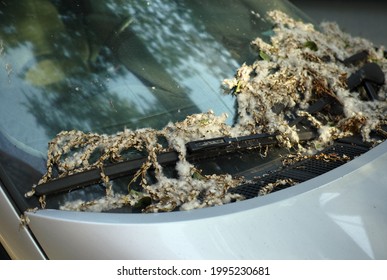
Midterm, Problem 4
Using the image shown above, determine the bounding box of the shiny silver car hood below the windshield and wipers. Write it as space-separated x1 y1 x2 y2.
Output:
28 142 387 259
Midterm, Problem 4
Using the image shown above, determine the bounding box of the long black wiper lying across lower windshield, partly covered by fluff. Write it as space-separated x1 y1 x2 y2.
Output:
34 96 336 196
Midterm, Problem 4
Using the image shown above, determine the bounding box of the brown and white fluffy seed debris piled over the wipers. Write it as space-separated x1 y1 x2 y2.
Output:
28 11 387 212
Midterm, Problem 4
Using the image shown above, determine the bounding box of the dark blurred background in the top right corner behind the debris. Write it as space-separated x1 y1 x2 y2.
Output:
289 0 387 48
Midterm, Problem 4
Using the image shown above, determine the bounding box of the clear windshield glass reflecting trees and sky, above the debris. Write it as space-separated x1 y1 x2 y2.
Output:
0 0 310 211
